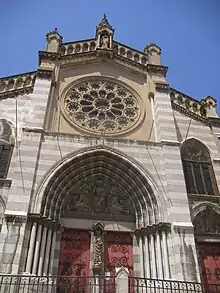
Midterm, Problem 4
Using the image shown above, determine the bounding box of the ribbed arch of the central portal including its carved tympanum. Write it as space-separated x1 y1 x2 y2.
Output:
34 146 162 228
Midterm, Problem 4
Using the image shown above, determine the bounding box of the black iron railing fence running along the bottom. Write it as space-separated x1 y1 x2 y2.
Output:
0 275 220 293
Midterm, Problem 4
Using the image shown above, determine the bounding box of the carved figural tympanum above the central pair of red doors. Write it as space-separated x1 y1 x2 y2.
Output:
61 175 135 221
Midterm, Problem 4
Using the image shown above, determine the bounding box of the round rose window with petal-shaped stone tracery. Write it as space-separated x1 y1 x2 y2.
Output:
64 80 140 134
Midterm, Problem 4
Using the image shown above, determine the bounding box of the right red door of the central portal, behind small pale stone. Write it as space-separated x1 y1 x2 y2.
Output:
104 232 134 293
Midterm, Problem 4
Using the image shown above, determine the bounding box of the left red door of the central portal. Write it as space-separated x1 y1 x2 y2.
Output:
58 229 90 293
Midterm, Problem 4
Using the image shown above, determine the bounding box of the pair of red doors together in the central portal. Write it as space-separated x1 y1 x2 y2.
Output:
58 229 134 292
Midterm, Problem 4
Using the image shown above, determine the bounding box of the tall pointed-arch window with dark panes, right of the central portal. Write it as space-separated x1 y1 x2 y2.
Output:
181 139 218 195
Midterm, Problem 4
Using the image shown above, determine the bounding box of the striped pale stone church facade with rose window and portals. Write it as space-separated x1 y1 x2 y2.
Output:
0 16 220 292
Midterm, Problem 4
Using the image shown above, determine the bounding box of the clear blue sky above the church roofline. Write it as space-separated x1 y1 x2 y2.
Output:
0 0 220 109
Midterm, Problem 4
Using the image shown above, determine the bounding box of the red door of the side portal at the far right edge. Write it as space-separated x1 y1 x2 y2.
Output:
198 242 220 293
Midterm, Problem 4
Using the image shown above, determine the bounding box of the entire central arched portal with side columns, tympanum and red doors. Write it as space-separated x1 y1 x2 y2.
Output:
25 146 170 278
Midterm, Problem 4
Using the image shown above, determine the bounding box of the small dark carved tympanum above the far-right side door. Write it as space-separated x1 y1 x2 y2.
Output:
193 208 220 235
